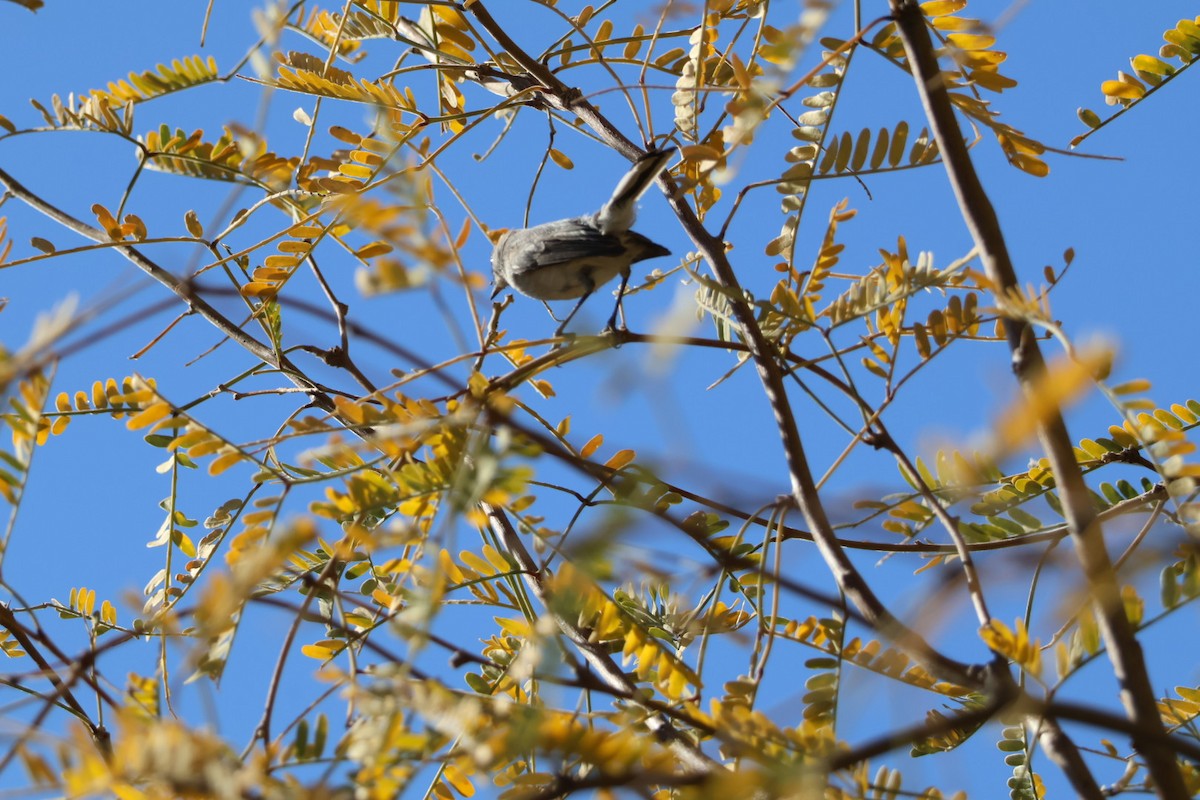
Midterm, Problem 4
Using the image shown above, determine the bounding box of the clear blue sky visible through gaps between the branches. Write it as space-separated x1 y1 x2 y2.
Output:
0 0 1200 796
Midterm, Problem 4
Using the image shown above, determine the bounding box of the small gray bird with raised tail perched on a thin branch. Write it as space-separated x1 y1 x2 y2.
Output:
492 148 674 336
